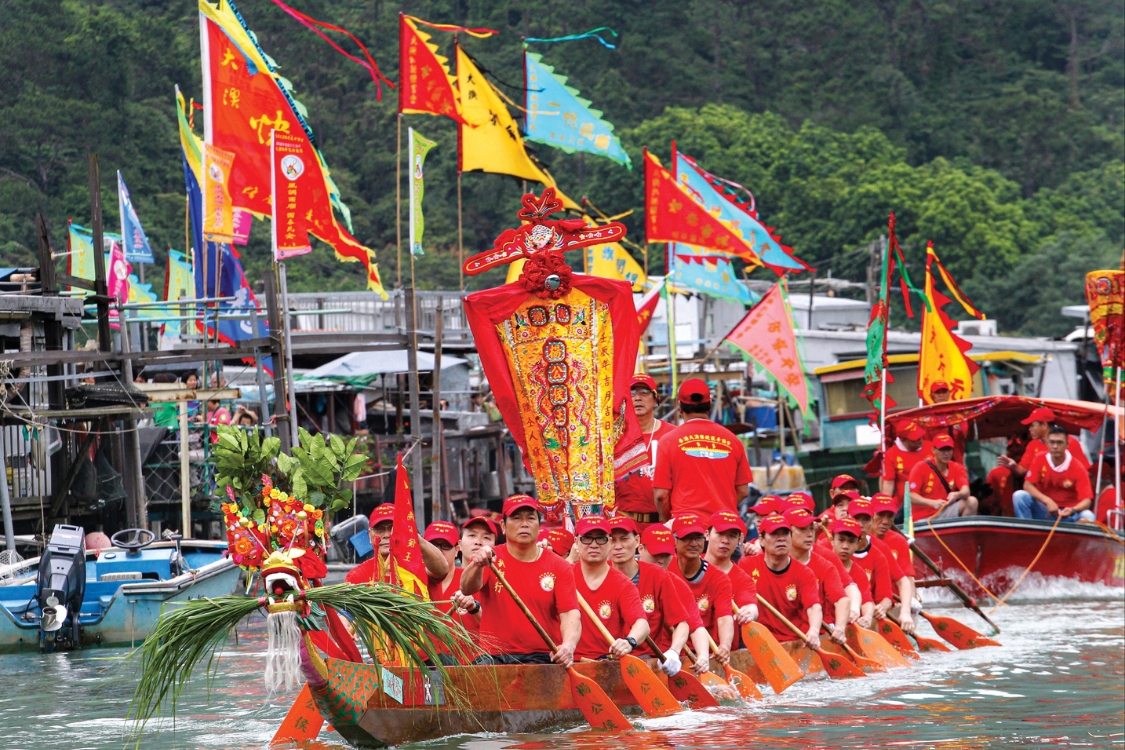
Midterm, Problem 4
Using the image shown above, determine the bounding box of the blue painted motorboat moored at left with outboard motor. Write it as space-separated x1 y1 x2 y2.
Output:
0 524 241 653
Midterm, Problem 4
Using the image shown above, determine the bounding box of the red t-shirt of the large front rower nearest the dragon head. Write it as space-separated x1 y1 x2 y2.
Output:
474 544 578 653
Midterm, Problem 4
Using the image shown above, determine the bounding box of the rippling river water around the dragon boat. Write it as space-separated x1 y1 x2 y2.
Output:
0 585 1125 750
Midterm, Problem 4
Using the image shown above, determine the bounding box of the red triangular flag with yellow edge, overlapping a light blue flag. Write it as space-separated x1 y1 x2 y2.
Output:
645 151 757 261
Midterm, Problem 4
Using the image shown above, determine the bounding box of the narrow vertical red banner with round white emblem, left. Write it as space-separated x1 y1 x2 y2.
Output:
270 130 316 261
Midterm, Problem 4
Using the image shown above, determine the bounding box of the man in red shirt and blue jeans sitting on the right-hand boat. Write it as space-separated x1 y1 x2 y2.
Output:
1011 425 1095 523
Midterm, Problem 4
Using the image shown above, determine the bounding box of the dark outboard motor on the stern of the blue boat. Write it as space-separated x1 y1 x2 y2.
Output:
36 524 86 651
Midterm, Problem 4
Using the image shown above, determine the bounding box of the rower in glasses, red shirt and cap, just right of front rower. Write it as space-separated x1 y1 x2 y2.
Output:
574 515 649 659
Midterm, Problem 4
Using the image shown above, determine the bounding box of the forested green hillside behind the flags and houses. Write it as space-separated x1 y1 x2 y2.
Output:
0 0 1125 334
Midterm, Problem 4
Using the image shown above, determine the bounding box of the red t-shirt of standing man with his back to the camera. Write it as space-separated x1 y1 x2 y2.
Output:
653 419 752 519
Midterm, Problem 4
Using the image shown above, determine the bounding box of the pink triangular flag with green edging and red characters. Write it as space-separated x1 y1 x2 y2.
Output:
726 281 809 413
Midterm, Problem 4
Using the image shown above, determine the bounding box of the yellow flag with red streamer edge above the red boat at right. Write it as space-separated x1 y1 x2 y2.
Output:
918 242 984 404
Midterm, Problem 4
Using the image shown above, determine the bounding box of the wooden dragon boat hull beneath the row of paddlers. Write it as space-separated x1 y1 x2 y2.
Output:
309 641 844 748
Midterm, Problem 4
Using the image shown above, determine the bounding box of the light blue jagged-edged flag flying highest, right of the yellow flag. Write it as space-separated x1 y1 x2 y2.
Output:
523 51 632 169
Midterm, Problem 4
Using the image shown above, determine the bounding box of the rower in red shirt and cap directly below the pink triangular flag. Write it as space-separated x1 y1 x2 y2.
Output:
739 515 824 649
